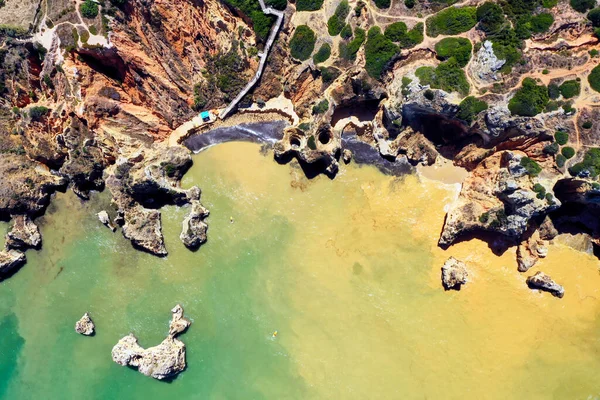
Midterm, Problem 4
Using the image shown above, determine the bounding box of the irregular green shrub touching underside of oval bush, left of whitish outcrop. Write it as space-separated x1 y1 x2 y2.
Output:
415 57 470 96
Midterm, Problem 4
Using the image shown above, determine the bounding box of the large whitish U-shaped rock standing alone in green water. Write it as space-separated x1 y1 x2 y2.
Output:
112 304 191 379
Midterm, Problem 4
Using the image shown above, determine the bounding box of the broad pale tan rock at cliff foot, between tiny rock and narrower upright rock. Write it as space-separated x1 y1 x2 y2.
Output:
123 206 167 256
